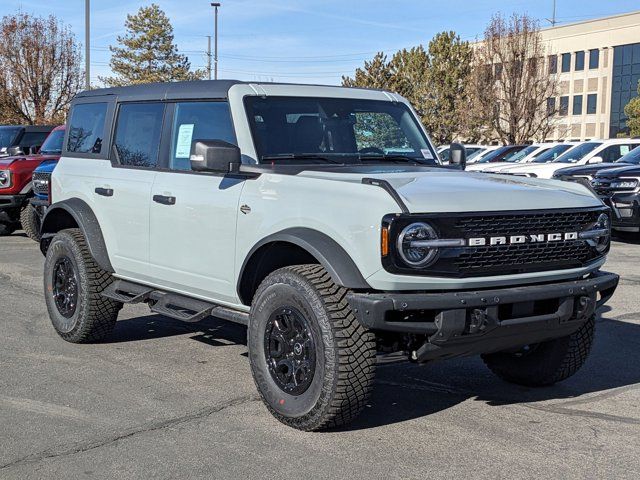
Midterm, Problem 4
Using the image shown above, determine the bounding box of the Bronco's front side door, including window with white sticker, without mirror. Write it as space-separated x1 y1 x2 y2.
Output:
150 101 243 303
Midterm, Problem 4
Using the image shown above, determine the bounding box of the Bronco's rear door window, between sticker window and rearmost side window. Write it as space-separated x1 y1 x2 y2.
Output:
113 103 164 168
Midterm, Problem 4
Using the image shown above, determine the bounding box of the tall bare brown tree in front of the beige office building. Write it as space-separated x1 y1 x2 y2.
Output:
468 14 558 143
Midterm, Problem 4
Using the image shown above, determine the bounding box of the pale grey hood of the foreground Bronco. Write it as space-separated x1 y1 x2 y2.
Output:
298 169 602 213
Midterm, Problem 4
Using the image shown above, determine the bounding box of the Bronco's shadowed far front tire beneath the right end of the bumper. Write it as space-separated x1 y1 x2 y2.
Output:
482 316 595 387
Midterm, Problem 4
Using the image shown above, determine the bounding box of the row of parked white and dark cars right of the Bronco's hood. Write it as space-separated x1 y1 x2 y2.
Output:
456 138 640 232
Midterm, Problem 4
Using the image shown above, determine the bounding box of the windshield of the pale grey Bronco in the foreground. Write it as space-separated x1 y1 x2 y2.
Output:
245 97 439 165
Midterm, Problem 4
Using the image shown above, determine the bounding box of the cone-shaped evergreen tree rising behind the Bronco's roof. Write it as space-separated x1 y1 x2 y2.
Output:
100 3 204 87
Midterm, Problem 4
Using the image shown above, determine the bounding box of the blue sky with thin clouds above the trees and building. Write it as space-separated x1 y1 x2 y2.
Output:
0 0 640 84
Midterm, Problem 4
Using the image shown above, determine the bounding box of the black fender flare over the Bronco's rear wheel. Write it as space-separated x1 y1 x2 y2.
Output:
40 198 114 273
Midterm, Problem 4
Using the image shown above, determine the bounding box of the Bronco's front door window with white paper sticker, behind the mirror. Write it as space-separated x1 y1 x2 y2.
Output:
169 102 236 170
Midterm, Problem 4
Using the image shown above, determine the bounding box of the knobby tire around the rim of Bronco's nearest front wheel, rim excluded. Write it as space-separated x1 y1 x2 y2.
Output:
248 265 376 431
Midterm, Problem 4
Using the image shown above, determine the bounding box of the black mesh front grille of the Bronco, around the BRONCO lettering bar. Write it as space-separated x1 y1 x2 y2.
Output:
383 207 608 277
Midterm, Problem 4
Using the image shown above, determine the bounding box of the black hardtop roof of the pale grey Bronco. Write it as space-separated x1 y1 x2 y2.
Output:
75 80 388 100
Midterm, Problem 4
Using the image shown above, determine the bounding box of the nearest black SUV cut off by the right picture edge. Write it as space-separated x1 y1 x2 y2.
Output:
591 148 640 232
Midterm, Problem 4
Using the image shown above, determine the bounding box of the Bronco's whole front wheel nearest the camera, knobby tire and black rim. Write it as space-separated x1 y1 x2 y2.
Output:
248 265 376 431
